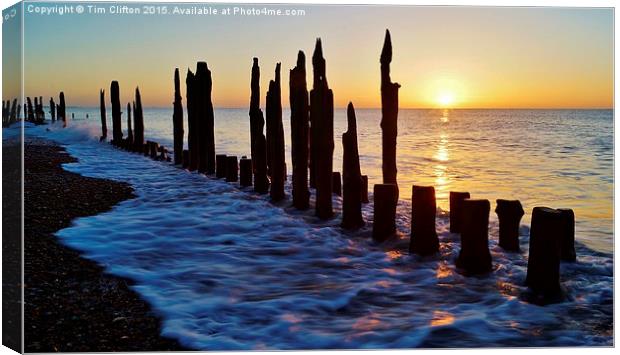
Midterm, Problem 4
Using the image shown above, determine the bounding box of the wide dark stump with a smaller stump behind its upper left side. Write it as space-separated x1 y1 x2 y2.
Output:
456 199 492 274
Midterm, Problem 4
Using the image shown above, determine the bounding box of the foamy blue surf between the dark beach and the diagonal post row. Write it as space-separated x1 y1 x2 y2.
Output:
21 124 613 350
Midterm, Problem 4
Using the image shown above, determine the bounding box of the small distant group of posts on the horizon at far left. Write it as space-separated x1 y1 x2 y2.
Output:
2 92 67 127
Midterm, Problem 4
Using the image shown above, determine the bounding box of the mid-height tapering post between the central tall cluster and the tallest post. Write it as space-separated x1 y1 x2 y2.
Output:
338 102 368 229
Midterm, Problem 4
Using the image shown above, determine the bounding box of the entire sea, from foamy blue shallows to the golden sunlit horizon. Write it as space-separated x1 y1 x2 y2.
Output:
12 107 614 350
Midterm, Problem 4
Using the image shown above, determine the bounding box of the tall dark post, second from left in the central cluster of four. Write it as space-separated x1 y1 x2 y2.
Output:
266 63 286 202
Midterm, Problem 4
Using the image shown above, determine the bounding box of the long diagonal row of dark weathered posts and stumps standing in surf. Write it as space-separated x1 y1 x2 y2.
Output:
100 31 575 304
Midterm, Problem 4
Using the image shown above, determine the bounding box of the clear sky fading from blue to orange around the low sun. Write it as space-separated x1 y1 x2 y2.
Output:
5 3 613 108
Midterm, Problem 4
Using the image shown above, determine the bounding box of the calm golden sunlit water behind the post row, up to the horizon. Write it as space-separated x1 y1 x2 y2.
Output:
63 107 614 251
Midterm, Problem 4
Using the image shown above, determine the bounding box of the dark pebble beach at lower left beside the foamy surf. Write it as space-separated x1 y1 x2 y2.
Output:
22 138 190 352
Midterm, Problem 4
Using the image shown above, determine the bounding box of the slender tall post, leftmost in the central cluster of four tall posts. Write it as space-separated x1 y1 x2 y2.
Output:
250 58 269 194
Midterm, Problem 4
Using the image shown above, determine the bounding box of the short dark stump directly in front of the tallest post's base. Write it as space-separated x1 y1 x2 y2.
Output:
372 184 398 242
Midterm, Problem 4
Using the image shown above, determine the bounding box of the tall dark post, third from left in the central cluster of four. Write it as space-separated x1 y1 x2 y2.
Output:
289 51 310 210
